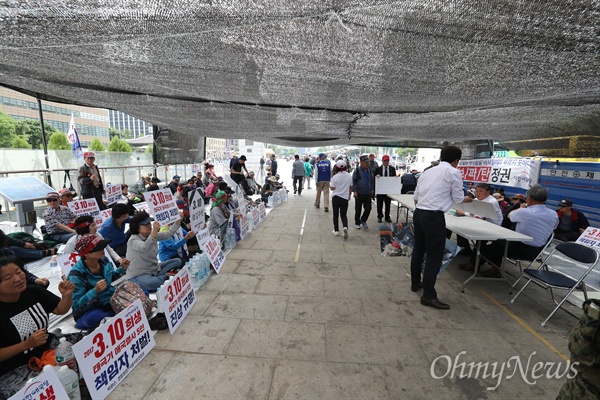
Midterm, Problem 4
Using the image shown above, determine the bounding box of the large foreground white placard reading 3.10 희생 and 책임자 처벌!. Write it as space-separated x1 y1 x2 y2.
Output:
73 299 155 399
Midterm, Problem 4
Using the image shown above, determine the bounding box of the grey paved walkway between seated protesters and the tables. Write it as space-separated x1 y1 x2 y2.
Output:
110 189 577 400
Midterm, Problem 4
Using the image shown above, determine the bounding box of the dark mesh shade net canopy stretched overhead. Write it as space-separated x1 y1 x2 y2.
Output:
0 0 600 159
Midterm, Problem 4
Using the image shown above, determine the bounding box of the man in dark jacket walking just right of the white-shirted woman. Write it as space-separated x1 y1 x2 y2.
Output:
352 155 375 229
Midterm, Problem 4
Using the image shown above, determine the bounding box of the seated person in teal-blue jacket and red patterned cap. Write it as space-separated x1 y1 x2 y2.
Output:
68 235 127 329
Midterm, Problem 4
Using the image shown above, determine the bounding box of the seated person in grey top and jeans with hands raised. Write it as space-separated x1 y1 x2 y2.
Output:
127 211 181 292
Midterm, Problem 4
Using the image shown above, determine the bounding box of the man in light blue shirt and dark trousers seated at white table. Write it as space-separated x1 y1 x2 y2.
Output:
481 185 558 277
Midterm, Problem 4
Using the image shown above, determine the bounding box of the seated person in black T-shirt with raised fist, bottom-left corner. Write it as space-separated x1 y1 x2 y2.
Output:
0 255 75 398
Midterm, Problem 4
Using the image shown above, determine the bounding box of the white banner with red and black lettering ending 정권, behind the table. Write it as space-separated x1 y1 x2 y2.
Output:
456 157 542 189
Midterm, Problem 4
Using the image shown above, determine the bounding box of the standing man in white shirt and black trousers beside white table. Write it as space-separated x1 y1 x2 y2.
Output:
410 146 473 310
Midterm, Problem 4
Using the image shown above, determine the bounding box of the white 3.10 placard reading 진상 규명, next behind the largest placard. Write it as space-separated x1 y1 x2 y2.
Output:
158 266 196 335
